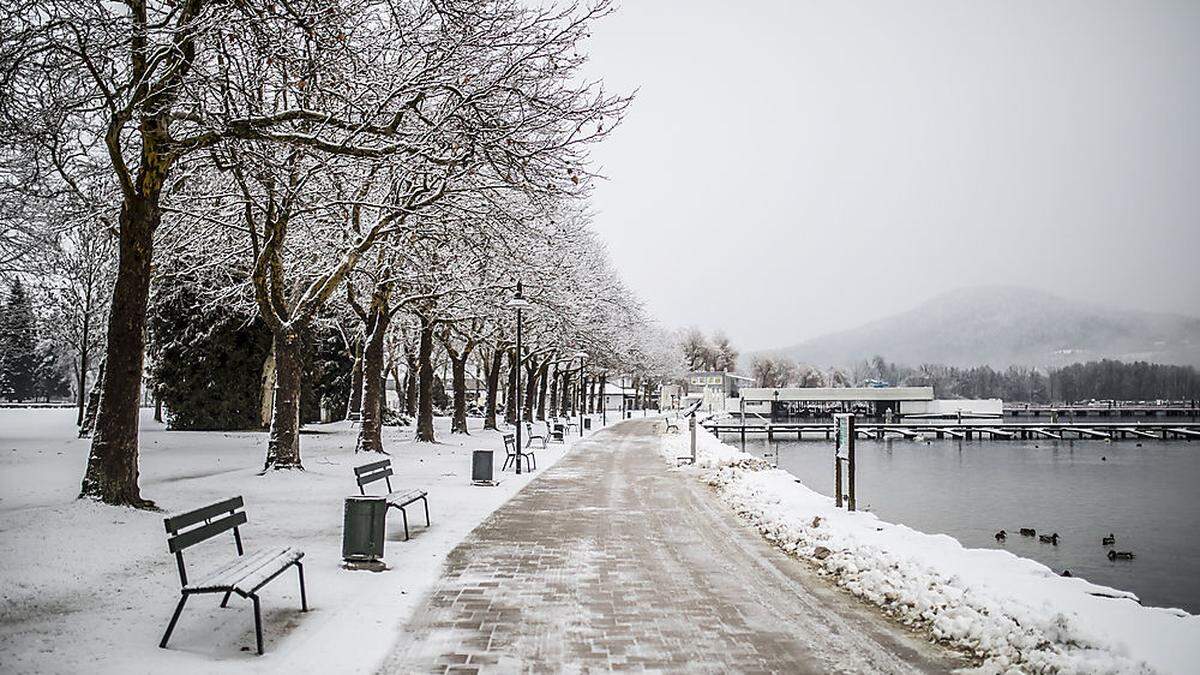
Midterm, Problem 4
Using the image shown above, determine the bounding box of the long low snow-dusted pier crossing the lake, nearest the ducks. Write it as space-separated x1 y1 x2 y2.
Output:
702 420 1200 441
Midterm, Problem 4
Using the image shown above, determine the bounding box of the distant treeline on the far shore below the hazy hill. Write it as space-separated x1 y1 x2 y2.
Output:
751 356 1200 404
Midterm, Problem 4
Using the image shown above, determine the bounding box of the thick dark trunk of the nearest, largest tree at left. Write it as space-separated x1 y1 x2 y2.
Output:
79 196 156 508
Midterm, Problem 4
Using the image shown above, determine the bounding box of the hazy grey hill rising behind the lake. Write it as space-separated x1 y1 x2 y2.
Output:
746 286 1200 368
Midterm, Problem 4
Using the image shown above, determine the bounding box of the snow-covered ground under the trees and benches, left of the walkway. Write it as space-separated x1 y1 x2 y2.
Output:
0 408 604 673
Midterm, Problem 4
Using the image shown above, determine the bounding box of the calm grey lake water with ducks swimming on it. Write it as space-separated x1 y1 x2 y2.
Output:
722 427 1200 614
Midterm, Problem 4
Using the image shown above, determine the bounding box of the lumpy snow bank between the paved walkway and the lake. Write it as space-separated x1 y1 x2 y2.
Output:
662 431 1200 673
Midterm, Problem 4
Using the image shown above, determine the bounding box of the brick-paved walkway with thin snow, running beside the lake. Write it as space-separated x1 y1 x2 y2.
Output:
383 420 964 673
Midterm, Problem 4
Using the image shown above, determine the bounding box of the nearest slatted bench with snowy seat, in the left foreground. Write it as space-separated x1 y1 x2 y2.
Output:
158 497 308 653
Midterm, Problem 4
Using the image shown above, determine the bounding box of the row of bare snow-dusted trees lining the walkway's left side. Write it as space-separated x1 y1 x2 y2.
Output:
0 0 668 507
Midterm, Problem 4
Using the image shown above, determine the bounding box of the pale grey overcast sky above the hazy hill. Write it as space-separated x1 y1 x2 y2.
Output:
588 0 1200 351
